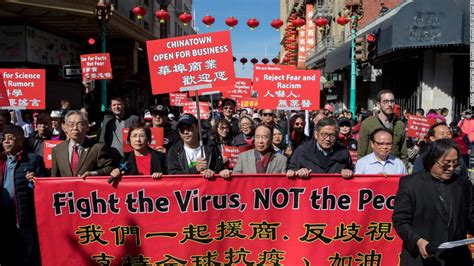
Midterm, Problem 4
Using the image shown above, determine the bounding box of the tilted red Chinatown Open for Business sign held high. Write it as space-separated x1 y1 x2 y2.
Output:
146 31 234 94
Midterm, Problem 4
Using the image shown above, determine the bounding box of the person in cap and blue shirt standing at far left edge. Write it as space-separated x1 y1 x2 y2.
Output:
0 125 46 265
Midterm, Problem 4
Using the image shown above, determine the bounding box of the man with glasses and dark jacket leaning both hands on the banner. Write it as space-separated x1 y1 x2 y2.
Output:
287 118 352 178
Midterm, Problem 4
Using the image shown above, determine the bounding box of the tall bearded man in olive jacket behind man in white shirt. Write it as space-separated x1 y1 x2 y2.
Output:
357 90 408 163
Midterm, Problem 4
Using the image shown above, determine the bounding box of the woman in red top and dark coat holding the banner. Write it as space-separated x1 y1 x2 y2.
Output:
110 123 167 179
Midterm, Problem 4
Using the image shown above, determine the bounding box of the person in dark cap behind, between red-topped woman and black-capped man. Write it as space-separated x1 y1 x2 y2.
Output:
150 104 179 154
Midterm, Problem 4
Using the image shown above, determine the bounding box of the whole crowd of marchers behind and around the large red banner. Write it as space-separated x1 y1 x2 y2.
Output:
0 90 474 265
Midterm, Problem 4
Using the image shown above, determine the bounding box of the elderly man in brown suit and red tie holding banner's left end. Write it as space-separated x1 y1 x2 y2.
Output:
51 111 113 178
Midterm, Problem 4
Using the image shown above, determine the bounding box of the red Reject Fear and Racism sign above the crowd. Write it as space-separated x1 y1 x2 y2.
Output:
253 64 320 110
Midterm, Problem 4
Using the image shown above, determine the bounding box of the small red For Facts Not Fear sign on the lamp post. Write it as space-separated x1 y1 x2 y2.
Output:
81 53 112 80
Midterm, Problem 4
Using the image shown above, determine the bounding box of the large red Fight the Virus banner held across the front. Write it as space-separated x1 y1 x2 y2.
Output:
34 175 401 266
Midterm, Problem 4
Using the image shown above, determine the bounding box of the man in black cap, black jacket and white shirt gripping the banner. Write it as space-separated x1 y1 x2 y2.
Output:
167 114 228 178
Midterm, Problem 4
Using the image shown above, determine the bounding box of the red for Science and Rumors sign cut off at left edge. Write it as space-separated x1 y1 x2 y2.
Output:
0 69 46 110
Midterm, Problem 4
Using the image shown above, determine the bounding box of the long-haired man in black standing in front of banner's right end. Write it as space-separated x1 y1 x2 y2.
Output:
392 139 474 266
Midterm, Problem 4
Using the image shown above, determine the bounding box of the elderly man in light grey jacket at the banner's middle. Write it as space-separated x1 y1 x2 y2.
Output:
233 124 287 174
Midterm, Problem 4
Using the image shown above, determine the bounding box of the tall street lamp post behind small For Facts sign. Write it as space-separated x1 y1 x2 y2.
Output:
95 0 113 112
